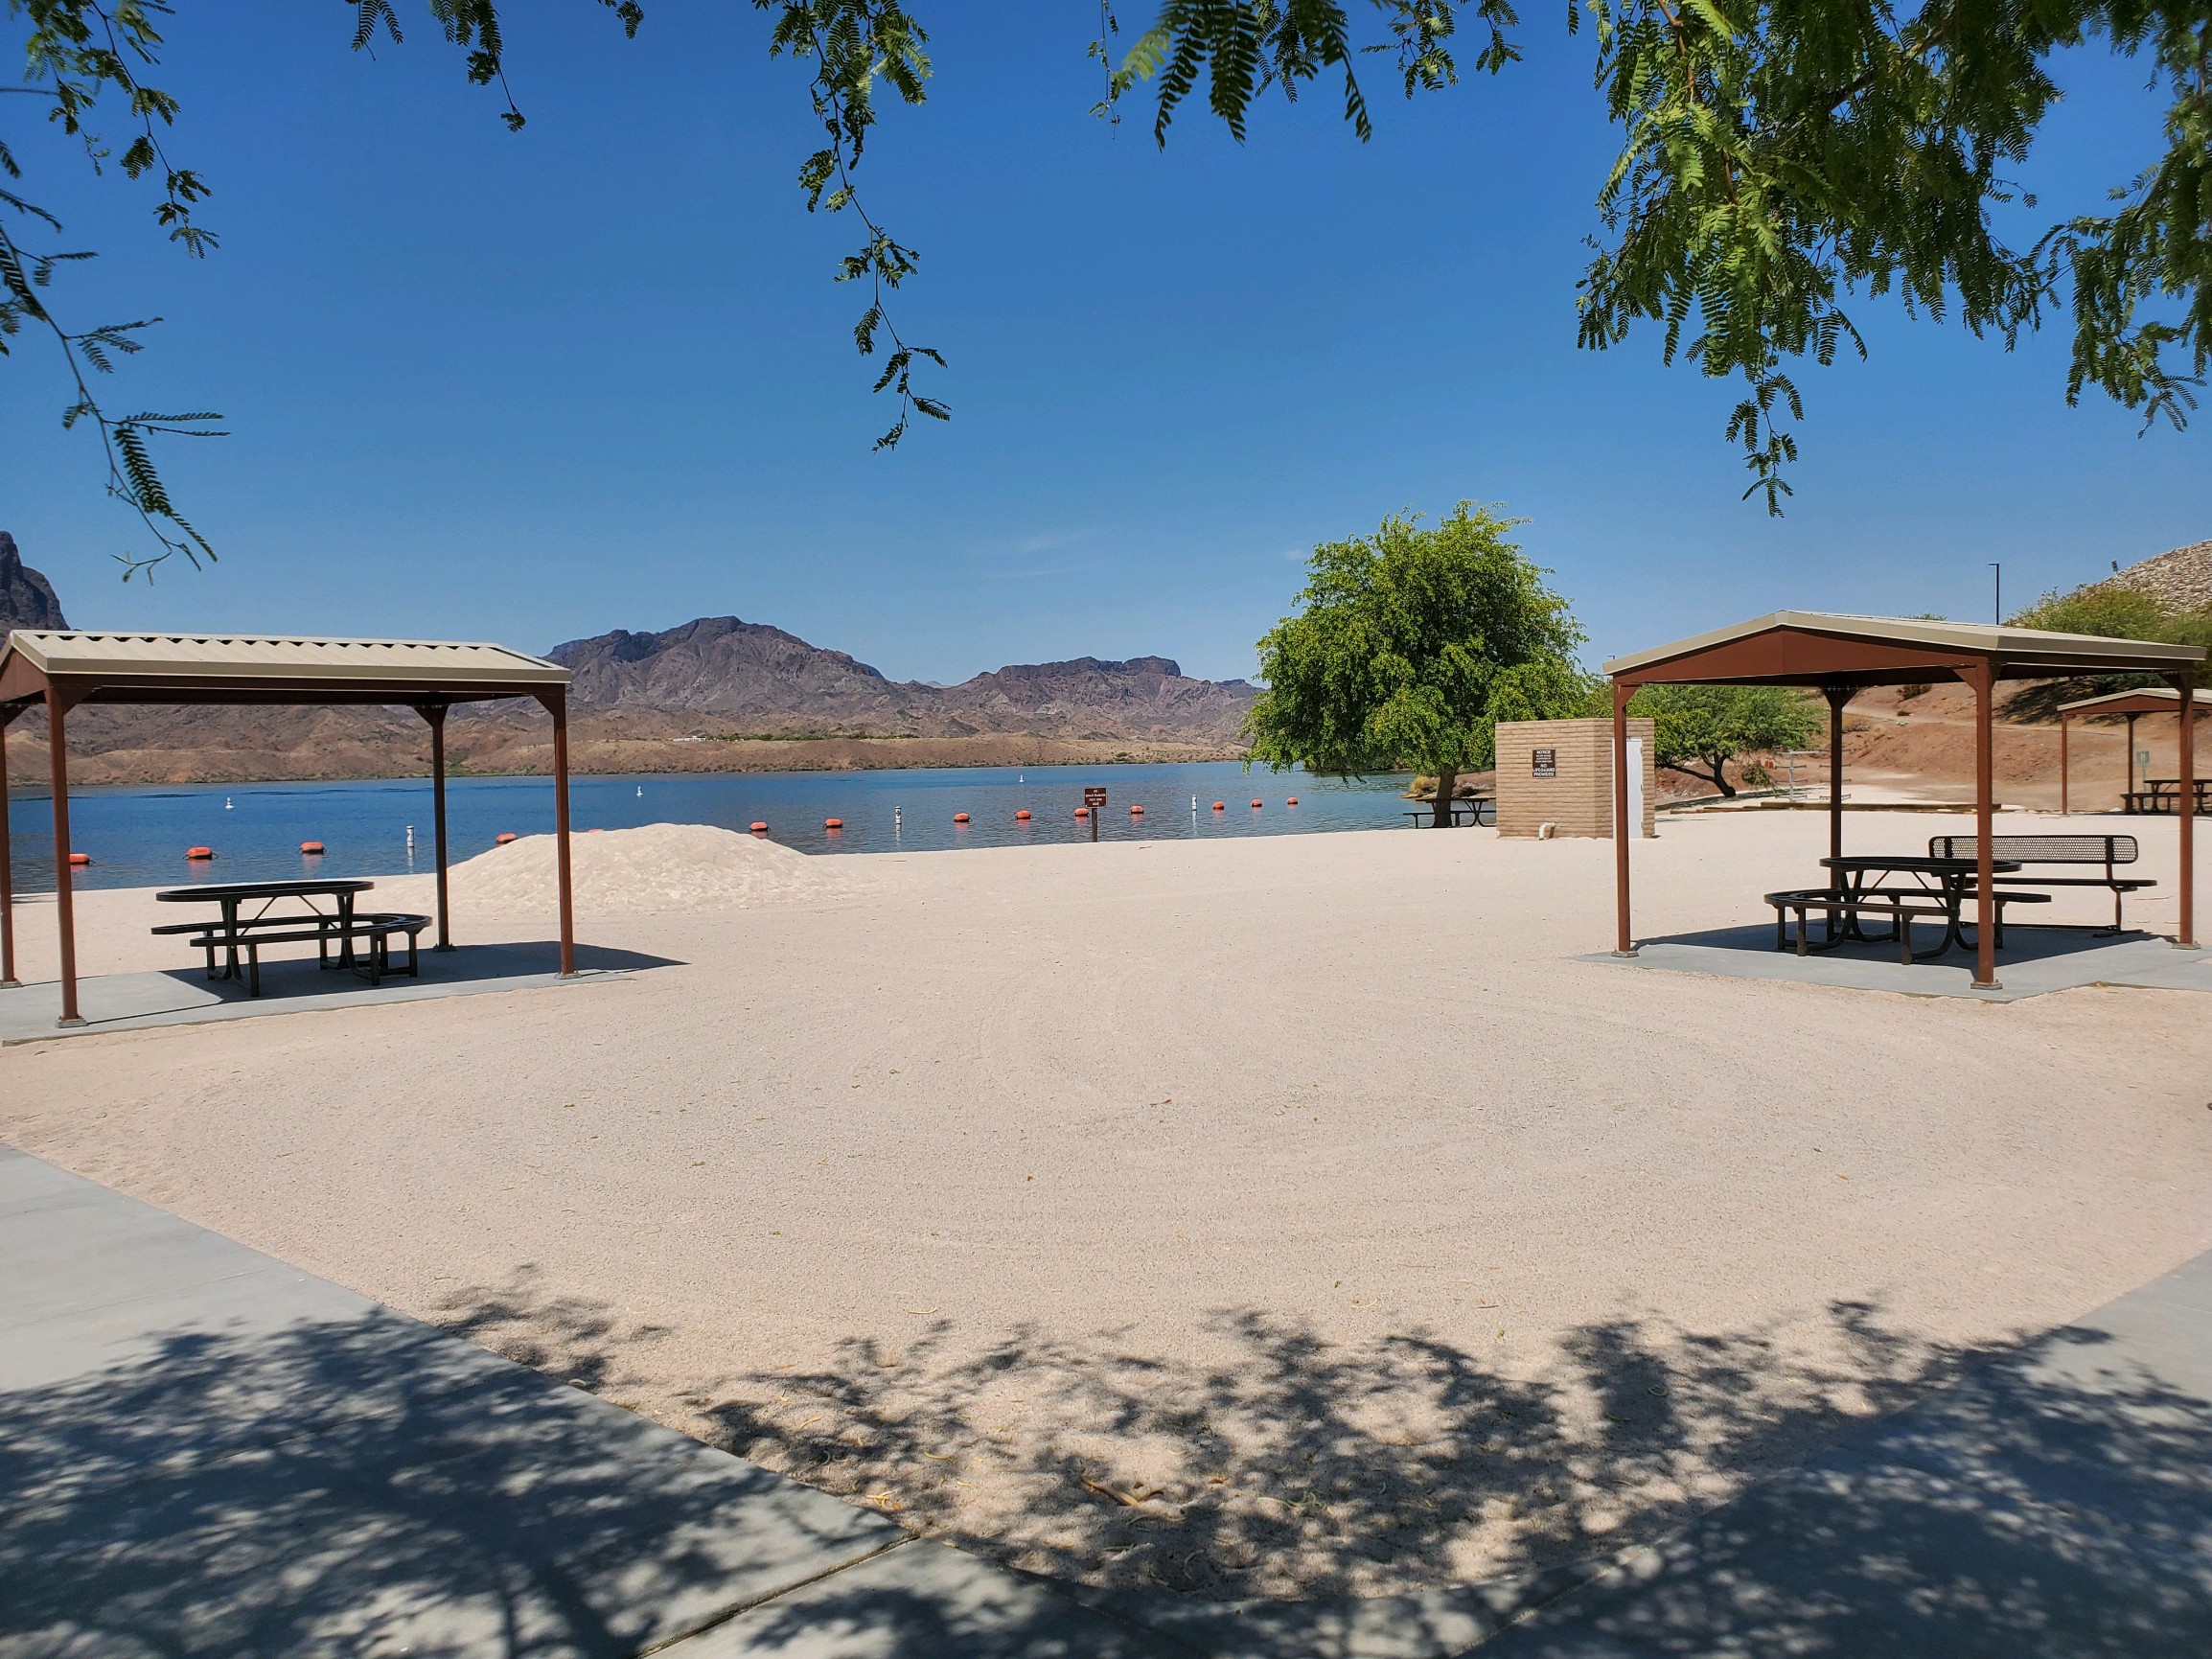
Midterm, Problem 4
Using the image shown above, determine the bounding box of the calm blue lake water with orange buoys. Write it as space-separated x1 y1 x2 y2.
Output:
9 761 1407 891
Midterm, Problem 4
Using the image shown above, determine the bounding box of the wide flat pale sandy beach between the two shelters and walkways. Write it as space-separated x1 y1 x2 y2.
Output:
0 812 2212 1597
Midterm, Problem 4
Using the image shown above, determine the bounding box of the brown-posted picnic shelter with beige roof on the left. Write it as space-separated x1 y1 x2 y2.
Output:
0 628 575 1025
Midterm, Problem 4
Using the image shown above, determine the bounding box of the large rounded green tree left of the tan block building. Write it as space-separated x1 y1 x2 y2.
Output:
1245 502 1588 825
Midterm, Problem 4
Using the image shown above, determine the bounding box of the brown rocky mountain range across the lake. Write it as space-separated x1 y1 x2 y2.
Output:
0 533 1258 783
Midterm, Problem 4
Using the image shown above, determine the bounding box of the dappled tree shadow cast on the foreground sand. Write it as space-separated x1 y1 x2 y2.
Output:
431 1280 2008 1601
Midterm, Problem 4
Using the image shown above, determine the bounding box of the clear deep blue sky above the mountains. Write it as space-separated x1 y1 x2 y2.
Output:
0 0 2212 680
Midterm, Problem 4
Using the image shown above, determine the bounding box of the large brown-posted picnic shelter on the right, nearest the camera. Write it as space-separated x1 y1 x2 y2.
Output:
1603 611 2205 986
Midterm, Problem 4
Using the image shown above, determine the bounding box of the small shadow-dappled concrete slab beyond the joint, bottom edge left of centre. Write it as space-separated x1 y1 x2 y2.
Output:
666 1542 1208 1659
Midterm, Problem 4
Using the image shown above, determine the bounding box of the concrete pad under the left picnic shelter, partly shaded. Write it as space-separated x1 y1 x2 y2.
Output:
0 945 668 1047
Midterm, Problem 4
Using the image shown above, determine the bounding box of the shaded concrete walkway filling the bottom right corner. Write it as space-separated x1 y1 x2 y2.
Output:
1482 1256 2212 1659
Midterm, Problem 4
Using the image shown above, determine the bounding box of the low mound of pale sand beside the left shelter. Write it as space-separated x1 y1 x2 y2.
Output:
451 823 859 916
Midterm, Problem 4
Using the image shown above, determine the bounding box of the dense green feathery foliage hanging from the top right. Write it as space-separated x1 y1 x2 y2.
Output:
1111 0 2212 513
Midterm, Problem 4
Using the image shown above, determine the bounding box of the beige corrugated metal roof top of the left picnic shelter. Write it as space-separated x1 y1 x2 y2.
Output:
0 628 570 685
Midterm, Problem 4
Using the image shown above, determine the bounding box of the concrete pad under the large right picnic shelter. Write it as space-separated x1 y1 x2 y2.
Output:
1578 927 2212 1002
